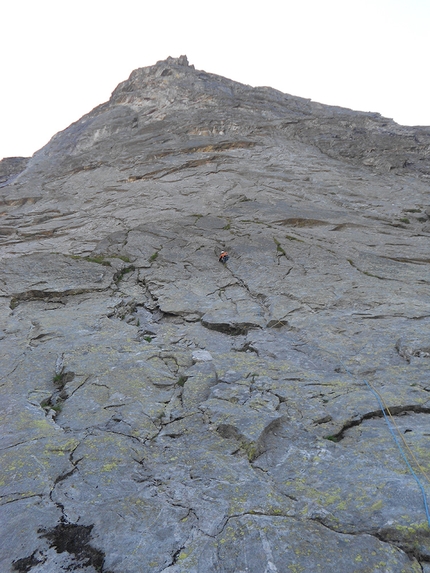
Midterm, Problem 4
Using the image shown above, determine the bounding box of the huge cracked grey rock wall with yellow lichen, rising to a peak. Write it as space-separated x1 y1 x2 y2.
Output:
0 56 430 573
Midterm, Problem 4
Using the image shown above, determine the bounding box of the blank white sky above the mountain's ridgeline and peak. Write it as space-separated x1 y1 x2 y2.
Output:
0 0 430 159
